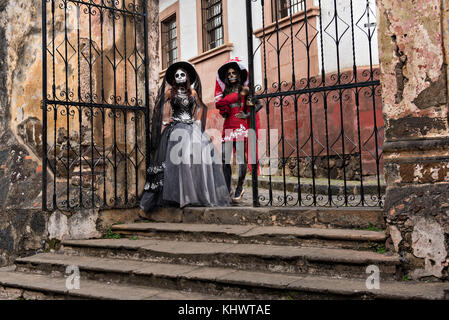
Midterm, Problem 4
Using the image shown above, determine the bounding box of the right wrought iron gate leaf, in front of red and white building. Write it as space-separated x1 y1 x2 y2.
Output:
246 0 385 206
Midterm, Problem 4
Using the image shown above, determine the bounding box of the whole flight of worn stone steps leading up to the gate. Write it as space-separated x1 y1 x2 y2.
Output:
0 208 449 300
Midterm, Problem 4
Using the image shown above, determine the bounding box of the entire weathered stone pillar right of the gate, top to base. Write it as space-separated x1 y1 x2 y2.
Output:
377 0 449 279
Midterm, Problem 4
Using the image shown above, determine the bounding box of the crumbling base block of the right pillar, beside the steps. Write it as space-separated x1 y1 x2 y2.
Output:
385 184 449 280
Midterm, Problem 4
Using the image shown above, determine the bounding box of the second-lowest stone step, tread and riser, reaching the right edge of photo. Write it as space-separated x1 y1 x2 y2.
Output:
15 254 449 300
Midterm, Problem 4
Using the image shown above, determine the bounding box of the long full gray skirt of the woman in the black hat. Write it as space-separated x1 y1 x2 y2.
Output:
140 122 230 212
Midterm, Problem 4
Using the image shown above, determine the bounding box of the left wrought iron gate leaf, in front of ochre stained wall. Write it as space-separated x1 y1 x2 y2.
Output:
42 0 149 210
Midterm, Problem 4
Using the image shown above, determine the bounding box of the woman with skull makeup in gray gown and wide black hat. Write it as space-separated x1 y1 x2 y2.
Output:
140 62 230 213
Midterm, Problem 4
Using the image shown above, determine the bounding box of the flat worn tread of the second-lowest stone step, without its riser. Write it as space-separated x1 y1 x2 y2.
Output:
13 254 449 299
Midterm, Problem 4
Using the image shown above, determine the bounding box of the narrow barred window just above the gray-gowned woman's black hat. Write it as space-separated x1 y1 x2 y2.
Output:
161 15 178 69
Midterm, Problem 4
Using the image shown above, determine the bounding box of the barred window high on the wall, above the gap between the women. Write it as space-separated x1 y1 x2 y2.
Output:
201 0 224 52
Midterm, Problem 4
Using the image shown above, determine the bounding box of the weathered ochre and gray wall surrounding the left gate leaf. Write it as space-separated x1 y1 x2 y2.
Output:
0 0 159 266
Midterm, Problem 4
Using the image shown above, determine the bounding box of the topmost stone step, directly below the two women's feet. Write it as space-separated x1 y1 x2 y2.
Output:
148 207 385 230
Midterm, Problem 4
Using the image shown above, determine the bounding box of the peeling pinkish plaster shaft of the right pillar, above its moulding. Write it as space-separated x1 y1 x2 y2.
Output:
377 0 448 140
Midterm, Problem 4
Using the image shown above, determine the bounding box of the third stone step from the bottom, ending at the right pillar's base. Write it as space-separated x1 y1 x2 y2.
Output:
62 239 400 279
